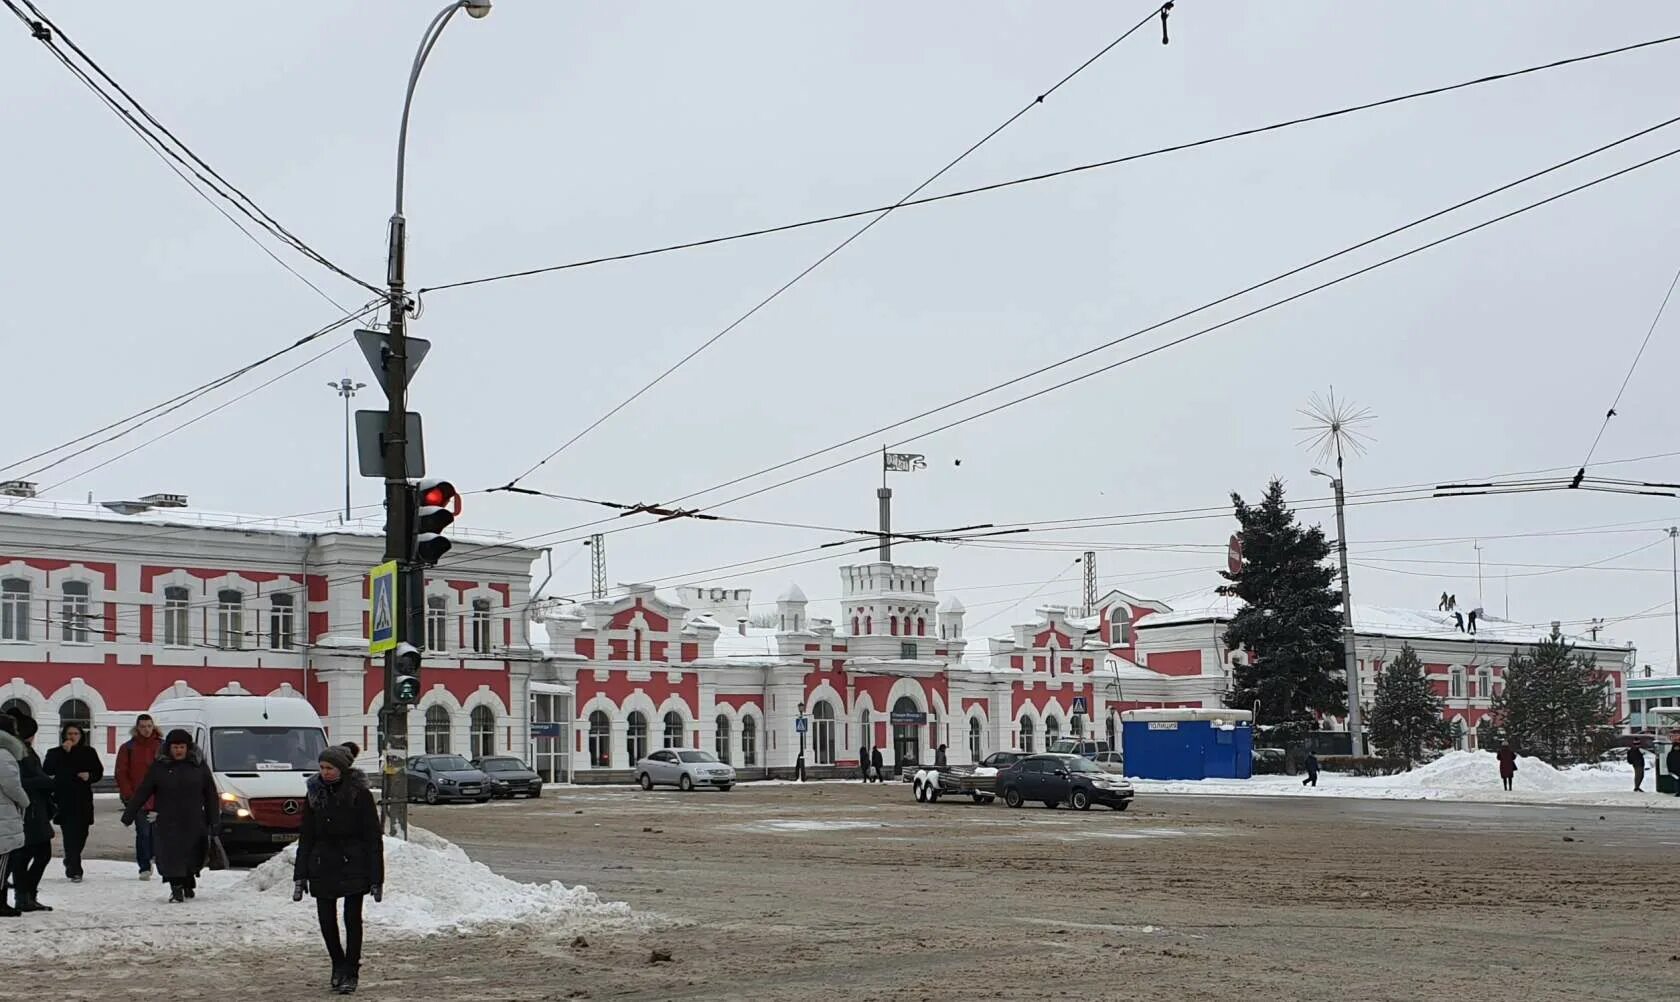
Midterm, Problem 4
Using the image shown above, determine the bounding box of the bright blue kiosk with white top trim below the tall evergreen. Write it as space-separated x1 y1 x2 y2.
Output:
1121 706 1253 780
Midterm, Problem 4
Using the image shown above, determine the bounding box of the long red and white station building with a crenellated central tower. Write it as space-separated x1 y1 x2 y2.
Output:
0 486 1633 782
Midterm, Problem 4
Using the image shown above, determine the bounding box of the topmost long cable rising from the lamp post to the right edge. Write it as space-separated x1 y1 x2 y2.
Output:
420 28 1680 294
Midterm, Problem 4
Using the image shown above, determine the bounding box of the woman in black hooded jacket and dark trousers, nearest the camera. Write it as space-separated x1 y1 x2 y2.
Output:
292 745 385 995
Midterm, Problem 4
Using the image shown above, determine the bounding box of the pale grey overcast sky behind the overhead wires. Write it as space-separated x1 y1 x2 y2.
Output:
0 0 1680 667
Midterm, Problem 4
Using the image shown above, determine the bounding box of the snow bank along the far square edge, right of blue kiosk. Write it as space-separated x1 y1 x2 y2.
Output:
1132 752 1680 809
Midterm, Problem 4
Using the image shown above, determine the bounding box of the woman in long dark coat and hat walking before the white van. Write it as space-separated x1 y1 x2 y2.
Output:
123 728 222 904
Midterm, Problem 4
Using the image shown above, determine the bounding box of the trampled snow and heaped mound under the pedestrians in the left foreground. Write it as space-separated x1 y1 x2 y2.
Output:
5 829 633 958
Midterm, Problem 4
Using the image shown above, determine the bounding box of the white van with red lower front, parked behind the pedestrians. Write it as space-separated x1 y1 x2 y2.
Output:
151 696 326 856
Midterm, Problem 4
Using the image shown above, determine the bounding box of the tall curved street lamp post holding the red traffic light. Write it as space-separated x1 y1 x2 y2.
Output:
381 0 491 839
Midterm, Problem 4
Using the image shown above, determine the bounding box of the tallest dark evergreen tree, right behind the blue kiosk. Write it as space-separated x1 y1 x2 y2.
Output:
1220 481 1347 725
